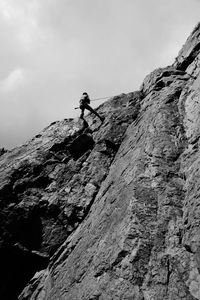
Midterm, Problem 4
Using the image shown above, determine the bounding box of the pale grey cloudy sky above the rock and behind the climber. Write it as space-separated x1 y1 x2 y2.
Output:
0 0 200 149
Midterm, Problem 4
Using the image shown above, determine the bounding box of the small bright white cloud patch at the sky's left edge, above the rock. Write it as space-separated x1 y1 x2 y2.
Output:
0 68 25 92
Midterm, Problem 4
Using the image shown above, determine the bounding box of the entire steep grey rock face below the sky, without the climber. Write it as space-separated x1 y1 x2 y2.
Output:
0 25 200 300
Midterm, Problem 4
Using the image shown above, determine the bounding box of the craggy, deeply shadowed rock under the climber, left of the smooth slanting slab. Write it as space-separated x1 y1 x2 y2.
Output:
0 92 141 300
